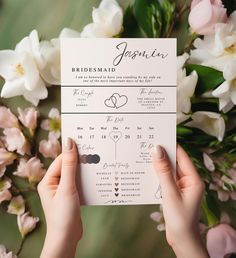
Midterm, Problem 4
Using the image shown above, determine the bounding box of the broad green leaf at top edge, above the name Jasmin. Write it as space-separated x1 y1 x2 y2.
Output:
134 0 162 38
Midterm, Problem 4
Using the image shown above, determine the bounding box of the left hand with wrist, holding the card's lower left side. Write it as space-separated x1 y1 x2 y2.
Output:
38 138 83 258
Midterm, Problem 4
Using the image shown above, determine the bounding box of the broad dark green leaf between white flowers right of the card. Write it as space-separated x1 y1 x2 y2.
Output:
186 64 225 95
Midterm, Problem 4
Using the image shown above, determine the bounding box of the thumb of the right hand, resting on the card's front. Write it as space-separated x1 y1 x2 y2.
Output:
152 145 179 199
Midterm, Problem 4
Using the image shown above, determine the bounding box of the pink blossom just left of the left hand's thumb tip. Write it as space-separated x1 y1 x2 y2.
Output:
39 135 61 159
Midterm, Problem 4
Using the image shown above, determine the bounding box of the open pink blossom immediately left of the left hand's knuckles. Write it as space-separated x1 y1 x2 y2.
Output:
13 157 46 184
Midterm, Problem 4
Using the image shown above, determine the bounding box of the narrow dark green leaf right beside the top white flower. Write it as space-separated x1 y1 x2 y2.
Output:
121 6 145 38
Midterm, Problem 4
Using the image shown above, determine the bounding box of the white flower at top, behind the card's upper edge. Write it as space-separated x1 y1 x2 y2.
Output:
81 0 123 38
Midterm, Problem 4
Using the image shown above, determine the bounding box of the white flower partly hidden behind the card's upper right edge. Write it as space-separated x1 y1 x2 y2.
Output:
177 53 198 124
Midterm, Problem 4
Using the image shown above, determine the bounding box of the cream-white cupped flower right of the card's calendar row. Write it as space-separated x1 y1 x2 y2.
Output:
186 111 225 141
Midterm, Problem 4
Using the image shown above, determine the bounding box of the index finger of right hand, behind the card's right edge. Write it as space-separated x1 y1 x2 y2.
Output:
177 145 200 179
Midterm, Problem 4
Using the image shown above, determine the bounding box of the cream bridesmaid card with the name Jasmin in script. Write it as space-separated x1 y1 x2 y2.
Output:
61 38 176 205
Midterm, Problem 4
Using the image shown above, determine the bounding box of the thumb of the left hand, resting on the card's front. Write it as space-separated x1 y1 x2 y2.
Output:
60 138 78 191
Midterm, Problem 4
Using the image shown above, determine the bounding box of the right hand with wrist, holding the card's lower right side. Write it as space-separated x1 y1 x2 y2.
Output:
152 145 209 258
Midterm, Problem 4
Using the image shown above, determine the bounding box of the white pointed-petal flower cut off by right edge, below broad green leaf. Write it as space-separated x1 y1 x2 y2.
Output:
212 58 236 113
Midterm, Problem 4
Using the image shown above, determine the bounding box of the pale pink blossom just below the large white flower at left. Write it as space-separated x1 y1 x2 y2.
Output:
17 107 38 132
